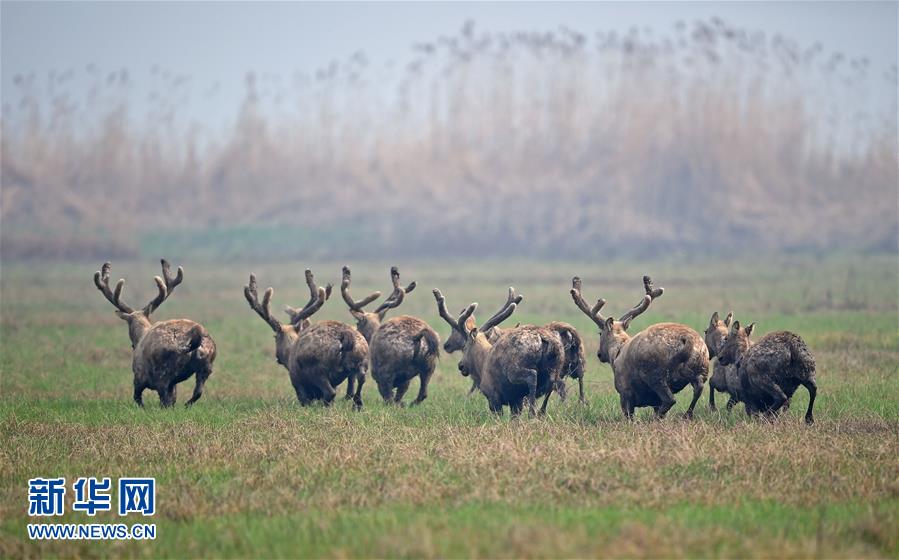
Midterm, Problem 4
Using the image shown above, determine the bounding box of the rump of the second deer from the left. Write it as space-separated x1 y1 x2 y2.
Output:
288 321 368 400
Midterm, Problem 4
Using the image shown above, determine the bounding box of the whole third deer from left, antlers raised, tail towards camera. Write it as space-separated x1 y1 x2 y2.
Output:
340 266 440 406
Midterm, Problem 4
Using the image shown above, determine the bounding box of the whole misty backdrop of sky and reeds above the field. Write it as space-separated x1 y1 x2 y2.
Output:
0 2 899 259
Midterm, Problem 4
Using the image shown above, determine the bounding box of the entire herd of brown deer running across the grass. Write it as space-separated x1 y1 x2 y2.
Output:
94 259 817 423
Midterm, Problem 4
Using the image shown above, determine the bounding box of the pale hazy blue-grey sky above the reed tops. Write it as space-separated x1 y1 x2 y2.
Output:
0 1 899 128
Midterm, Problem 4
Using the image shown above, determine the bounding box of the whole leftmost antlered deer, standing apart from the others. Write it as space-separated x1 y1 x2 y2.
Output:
94 259 216 407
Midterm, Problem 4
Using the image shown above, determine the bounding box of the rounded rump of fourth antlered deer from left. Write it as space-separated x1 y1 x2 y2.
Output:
481 325 565 412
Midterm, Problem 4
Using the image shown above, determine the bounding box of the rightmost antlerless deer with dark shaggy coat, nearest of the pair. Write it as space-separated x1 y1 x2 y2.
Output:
718 321 818 424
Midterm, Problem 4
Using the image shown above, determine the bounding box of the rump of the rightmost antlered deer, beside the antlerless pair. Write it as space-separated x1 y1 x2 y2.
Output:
614 323 709 406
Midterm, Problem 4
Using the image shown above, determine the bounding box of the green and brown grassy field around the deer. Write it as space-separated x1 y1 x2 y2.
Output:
0 256 899 558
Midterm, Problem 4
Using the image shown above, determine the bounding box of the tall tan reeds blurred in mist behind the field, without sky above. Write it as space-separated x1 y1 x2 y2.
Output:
2 19 899 257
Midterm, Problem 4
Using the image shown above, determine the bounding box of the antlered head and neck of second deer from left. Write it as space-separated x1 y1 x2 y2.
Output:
243 269 331 367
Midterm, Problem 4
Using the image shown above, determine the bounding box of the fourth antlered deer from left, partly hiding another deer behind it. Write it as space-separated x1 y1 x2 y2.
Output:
433 288 565 417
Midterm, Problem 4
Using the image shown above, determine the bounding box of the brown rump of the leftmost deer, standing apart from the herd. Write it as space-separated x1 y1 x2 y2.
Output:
132 319 216 390
